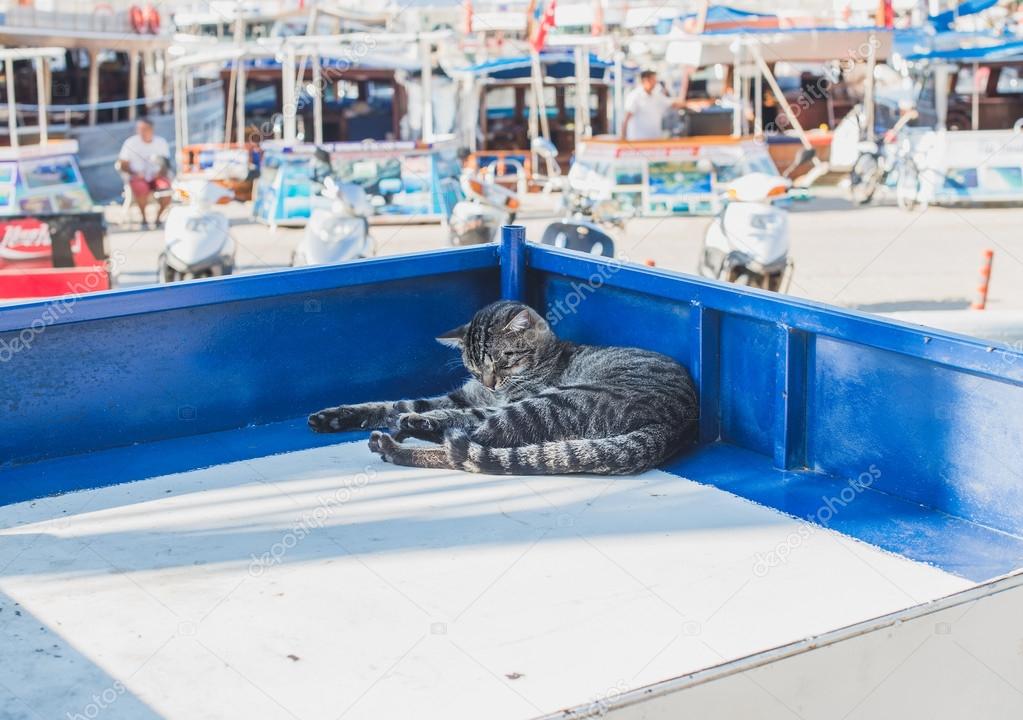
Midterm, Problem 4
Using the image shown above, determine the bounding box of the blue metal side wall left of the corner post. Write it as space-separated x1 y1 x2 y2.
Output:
0 246 498 465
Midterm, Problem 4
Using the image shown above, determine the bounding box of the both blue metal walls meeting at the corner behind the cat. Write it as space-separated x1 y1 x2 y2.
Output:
0 231 1023 573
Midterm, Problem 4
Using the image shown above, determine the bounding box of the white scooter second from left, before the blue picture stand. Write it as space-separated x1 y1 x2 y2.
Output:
292 177 373 266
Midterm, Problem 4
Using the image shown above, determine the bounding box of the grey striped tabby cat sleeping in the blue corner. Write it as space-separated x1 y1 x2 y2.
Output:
309 301 698 475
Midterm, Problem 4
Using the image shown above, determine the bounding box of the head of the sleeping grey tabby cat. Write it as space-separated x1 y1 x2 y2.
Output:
437 301 557 390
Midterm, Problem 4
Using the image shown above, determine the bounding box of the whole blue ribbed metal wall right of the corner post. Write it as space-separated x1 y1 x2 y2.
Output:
527 245 1023 540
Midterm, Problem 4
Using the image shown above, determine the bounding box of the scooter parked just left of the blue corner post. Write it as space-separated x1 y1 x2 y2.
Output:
447 168 519 245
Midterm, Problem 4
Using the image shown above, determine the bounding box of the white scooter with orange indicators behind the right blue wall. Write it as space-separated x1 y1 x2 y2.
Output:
700 173 793 293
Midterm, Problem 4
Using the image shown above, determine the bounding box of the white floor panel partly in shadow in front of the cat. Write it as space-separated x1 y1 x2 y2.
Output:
0 442 971 720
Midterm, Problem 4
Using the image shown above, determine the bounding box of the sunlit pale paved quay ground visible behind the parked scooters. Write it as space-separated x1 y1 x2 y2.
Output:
108 187 1023 335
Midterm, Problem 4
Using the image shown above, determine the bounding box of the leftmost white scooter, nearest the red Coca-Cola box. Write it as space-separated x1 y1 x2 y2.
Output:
158 180 234 282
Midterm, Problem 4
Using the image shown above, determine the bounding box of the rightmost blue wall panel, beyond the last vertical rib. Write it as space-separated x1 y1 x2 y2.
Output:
807 338 1023 534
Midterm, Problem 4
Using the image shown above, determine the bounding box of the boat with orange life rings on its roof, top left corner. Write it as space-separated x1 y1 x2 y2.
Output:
0 0 224 201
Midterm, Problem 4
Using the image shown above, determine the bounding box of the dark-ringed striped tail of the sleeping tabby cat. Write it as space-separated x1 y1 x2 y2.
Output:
444 418 697 475
